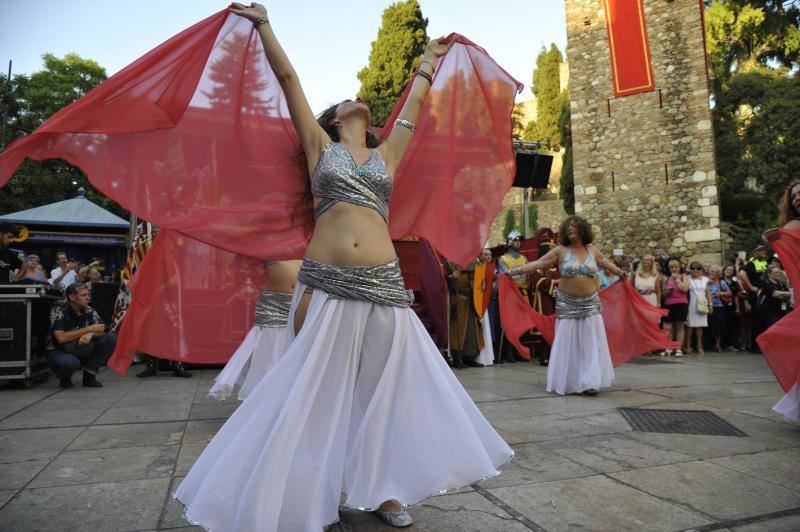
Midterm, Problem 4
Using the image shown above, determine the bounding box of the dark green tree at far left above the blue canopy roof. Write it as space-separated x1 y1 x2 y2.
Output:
0 54 127 217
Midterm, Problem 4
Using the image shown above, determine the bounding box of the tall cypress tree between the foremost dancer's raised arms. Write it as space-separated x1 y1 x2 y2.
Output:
358 0 428 126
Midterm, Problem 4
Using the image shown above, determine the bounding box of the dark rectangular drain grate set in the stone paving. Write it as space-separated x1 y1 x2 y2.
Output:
619 408 747 436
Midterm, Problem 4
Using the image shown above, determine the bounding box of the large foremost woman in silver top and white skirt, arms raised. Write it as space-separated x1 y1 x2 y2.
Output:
175 4 513 532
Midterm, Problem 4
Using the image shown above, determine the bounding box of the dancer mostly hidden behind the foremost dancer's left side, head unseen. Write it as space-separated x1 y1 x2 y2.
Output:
208 260 301 401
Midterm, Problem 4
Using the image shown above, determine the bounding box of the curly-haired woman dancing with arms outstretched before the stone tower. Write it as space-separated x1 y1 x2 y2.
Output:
509 216 625 395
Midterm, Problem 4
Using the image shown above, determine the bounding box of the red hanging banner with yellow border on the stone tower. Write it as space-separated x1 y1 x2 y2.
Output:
603 0 655 97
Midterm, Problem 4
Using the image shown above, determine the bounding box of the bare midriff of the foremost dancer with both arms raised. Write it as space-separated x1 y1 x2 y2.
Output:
306 201 397 266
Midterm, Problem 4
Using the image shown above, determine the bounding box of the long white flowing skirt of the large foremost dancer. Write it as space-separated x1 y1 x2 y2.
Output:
175 283 513 532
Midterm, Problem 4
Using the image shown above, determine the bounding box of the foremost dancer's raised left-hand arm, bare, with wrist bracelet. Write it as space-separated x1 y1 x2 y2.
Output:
228 2 331 173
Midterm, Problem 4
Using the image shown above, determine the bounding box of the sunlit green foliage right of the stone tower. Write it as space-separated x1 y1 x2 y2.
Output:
706 0 800 243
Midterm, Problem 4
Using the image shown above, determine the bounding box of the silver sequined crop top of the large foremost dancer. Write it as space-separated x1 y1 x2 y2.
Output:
311 142 392 221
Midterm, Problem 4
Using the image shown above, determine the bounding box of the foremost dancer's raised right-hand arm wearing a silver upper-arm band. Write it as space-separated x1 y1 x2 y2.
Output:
384 37 453 175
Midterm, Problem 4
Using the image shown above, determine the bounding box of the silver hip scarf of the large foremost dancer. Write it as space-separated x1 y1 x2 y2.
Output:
297 258 414 308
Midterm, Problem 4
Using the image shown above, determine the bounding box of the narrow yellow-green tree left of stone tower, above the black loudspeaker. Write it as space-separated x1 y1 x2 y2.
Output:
522 43 564 150
